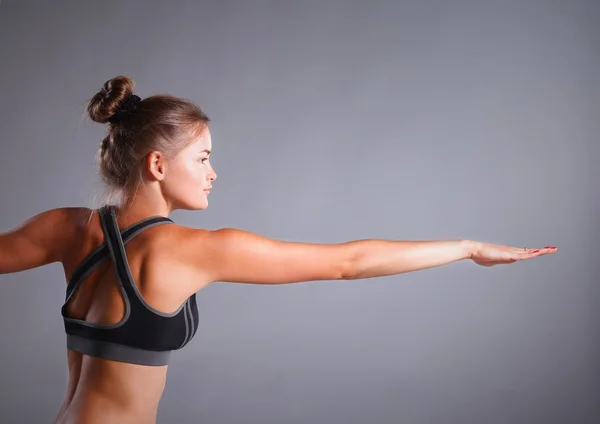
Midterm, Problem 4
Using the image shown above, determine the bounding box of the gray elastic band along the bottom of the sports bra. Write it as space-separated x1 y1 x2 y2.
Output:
67 334 171 366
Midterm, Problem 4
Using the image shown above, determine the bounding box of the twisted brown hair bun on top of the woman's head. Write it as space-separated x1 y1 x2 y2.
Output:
87 75 135 124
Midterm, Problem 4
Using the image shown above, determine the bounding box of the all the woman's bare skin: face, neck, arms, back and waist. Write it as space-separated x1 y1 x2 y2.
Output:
0 128 556 424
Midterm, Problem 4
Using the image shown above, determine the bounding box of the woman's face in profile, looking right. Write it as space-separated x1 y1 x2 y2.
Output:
162 127 217 210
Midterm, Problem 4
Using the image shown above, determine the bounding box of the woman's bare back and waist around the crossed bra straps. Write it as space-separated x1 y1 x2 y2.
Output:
55 208 212 424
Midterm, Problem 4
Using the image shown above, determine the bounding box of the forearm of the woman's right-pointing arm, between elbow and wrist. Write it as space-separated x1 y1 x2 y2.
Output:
347 240 476 280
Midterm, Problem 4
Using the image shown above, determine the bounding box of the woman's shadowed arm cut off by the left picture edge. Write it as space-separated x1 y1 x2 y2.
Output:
0 208 77 274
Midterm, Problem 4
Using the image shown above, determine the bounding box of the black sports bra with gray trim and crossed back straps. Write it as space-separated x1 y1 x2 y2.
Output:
61 205 198 366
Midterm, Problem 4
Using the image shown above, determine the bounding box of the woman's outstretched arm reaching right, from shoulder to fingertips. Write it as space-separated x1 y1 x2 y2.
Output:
186 228 551 288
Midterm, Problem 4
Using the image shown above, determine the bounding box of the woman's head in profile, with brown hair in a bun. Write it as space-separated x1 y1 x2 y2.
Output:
87 76 216 210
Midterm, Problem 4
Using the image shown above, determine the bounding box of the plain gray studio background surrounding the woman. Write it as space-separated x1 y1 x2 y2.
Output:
0 0 600 424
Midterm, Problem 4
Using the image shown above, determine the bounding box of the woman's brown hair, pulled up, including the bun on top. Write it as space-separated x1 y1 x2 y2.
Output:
87 75 210 209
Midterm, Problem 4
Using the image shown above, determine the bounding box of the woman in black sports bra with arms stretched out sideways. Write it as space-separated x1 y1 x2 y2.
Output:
0 76 556 424
